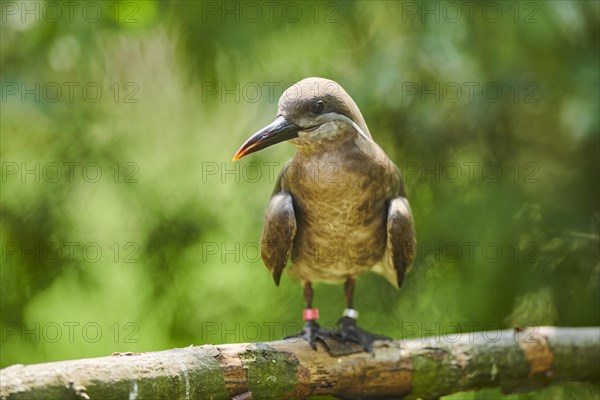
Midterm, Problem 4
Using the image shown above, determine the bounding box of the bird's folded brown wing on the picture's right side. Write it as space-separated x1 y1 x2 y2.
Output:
384 196 417 288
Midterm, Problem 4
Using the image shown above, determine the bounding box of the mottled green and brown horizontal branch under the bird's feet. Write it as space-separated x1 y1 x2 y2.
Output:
0 327 600 400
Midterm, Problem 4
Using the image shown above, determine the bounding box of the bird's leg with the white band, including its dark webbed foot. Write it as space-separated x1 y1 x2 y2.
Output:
334 277 391 353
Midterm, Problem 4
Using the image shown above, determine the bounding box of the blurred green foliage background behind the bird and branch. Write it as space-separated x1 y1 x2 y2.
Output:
0 1 600 399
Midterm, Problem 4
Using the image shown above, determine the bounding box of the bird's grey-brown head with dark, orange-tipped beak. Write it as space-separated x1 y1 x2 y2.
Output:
233 78 371 160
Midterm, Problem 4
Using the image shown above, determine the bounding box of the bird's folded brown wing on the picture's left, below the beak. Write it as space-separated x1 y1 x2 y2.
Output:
260 168 296 286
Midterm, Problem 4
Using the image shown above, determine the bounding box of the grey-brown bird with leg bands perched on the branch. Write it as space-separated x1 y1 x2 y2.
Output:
233 77 416 352
